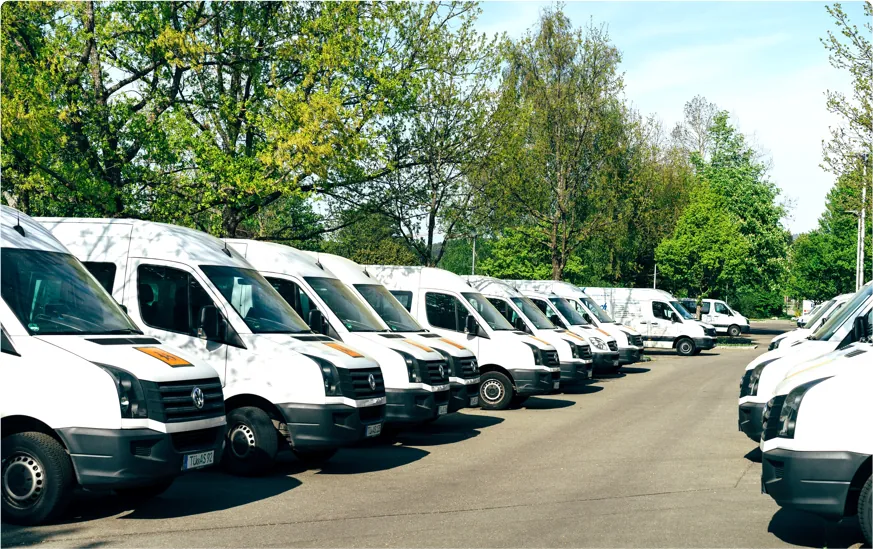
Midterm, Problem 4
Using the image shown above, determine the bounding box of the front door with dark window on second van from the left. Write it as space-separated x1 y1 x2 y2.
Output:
124 259 232 378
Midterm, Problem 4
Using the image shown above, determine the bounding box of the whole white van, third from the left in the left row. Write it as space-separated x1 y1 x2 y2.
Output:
227 239 449 425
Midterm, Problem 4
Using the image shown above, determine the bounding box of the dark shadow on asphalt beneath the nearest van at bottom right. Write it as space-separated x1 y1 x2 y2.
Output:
767 508 866 547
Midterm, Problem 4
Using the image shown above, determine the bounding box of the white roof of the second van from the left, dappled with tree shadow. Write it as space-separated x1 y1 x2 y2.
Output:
38 217 252 269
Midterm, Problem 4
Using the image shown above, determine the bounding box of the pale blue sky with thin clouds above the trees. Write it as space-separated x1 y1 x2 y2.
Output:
478 2 862 233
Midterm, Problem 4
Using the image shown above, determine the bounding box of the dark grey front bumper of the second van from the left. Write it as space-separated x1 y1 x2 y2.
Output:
278 404 385 450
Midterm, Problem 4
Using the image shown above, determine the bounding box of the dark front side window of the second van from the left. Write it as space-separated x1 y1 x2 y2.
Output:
136 265 215 337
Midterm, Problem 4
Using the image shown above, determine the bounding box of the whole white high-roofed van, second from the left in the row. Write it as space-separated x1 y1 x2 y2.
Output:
42 219 385 475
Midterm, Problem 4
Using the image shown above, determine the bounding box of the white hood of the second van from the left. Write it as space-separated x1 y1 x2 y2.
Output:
254 334 379 370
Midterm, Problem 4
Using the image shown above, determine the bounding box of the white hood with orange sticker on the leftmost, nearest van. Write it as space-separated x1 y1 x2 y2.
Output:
34 335 218 382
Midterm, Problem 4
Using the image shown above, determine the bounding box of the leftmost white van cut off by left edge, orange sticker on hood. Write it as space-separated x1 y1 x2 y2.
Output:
0 206 226 524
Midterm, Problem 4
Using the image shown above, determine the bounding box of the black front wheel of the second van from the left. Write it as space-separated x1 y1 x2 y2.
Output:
221 406 279 477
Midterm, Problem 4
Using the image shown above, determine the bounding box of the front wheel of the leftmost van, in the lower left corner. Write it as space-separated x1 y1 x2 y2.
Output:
2 432 76 526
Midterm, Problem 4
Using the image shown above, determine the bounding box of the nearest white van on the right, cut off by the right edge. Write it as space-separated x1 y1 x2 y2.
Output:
760 362 873 546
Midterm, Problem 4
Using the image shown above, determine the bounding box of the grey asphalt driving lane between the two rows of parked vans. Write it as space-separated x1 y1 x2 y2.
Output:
2 322 862 547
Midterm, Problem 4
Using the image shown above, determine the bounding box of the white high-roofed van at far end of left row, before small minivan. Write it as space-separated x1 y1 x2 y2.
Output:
582 287 716 356
